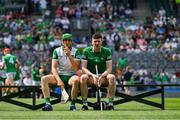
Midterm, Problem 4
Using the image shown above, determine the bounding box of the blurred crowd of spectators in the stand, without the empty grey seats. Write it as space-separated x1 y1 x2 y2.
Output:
0 0 180 88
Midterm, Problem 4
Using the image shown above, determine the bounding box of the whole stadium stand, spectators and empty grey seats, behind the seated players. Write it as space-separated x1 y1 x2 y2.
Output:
0 0 180 98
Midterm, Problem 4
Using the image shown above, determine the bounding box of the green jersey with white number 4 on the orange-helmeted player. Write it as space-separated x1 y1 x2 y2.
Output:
3 54 17 72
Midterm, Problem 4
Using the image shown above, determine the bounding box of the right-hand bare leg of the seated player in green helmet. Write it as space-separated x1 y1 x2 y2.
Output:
68 75 79 111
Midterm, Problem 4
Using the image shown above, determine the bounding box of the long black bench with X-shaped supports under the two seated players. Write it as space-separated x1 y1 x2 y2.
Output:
0 84 180 110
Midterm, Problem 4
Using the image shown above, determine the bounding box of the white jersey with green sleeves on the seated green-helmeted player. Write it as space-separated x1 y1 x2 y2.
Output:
52 46 80 76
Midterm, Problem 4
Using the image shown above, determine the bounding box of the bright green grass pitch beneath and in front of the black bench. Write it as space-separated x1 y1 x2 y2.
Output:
0 98 180 120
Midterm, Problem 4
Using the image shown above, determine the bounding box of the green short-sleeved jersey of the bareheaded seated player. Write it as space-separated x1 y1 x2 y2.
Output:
82 46 112 74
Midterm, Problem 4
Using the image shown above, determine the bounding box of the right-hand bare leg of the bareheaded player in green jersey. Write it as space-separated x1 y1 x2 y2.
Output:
101 74 116 110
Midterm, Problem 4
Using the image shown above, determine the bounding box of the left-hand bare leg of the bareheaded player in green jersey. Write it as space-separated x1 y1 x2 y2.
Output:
80 74 94 110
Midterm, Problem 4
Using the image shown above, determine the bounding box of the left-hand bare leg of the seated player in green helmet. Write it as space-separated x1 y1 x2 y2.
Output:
41 74 57 111
